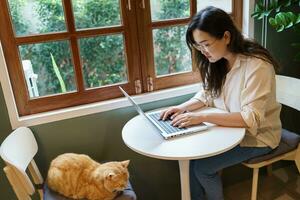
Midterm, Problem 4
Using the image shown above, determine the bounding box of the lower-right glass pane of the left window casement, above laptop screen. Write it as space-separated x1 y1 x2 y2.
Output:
79 35 127 88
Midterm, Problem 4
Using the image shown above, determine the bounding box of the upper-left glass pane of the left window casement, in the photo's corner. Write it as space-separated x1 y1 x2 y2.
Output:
8 0 66 36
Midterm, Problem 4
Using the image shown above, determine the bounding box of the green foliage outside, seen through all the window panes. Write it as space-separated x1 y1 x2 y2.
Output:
9 0 191 96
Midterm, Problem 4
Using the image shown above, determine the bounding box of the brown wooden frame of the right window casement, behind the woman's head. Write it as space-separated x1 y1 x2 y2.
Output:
138 0 243 91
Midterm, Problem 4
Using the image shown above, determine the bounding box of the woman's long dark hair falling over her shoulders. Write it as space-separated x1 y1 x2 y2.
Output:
186 6 279 97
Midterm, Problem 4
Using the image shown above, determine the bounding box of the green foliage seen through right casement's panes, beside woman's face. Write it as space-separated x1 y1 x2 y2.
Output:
153 0 191 76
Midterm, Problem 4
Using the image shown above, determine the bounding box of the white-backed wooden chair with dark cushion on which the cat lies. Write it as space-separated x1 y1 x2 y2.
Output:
0 127 136 200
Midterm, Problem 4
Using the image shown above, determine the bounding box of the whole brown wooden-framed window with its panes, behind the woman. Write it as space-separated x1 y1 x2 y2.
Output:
0 0 242 116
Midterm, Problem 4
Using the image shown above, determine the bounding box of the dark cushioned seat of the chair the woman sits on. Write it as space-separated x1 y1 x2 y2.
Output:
244 129 300 164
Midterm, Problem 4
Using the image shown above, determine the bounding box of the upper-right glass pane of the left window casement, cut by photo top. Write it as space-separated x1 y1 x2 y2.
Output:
72 0 121 29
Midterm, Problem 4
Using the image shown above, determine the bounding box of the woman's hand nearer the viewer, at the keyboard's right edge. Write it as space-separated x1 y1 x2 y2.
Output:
171 112 204 128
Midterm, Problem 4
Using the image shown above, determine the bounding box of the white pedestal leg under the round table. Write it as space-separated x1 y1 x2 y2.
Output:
178 160 191 200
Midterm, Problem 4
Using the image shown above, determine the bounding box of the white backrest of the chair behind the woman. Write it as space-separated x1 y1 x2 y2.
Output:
276 75 300 111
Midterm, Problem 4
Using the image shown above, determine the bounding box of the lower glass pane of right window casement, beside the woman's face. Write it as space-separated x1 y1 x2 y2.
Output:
153 26 192 76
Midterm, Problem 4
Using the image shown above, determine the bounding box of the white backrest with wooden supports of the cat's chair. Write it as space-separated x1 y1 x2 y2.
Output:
0 127 43 199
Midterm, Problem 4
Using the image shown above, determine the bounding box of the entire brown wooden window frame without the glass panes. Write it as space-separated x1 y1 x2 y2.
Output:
0 0 242 116
